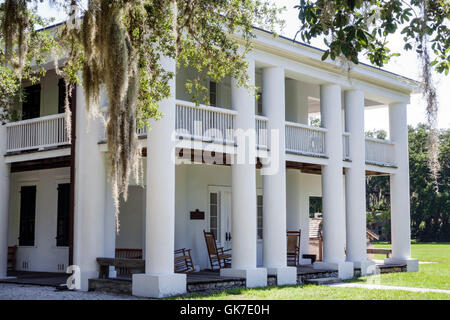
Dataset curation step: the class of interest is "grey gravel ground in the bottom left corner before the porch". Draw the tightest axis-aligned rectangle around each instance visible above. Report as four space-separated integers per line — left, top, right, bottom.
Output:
0 283 139 300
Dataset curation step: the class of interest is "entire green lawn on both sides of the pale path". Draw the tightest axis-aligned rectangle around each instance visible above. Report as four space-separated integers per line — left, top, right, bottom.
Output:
173 243 450 300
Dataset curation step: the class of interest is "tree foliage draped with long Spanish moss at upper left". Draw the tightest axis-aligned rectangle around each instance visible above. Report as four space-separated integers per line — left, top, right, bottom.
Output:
0 0 279 230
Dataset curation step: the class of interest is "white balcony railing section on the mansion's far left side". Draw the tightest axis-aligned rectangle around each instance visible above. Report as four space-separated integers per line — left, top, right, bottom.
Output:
6 113 70 152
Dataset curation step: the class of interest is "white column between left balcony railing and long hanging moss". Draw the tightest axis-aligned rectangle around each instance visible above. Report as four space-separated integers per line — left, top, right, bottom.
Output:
74 87 106 291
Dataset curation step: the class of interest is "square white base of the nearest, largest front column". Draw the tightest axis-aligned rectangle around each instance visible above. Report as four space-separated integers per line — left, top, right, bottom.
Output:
131 273 186 298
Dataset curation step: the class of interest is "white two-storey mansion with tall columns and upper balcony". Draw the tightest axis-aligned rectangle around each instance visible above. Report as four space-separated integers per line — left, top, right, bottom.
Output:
0 30 418 297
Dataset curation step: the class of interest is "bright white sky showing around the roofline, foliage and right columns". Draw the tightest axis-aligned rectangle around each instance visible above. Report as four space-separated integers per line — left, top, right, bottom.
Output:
39 0 450 131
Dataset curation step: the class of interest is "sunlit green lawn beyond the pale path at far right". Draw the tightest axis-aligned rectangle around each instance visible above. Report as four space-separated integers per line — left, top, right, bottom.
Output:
352 242 450 290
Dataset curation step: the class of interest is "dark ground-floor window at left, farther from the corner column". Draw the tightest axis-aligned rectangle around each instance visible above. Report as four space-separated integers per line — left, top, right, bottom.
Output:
19 186 36 246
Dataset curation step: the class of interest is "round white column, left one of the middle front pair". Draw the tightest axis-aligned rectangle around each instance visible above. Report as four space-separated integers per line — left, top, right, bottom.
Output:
220 58 267 287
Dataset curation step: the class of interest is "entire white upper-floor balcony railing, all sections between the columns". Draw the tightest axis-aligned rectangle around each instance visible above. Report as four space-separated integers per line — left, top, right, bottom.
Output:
6 104 395 166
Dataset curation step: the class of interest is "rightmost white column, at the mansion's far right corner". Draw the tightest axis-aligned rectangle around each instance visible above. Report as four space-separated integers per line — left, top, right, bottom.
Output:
385 103 419 271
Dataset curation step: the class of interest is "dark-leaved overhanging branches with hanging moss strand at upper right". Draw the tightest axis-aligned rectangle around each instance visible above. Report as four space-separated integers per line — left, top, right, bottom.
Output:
296 0 450 185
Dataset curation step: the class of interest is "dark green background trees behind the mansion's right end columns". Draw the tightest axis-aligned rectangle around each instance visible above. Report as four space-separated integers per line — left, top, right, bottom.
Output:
366 124 450 241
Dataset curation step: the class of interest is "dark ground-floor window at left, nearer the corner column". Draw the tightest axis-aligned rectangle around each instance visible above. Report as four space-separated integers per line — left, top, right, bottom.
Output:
56 183 70 247
